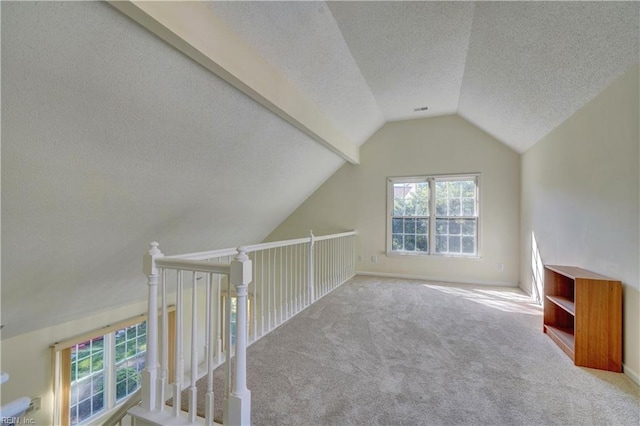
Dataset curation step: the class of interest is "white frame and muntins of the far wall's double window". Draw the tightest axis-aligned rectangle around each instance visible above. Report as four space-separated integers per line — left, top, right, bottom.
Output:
386 173 482 259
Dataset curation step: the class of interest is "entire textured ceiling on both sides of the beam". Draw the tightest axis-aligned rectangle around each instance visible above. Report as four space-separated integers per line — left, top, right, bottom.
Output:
1 1 640 338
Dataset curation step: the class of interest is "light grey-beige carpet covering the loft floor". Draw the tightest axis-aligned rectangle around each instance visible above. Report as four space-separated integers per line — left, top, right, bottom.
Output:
178 277 640 426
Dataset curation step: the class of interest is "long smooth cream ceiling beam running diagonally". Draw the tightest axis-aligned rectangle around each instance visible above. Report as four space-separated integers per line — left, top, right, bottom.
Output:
109 1 360 164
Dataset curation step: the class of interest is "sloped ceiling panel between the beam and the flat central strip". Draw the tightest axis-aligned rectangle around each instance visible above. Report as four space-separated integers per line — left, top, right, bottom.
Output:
208 1 385 144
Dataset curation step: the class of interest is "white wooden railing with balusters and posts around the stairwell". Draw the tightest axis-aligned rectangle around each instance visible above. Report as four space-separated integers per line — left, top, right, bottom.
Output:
131 231 357 425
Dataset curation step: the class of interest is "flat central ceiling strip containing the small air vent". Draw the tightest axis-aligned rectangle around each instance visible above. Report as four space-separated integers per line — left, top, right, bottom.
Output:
330 2 474 121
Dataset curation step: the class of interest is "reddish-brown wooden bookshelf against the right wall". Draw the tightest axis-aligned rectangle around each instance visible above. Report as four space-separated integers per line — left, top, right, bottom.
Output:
543 265 622 372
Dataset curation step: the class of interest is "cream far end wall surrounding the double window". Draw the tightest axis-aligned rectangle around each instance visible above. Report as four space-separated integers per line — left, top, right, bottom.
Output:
267 115 520 285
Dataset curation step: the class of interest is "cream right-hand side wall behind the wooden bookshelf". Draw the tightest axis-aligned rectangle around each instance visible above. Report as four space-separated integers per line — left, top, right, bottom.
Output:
520 66 640 381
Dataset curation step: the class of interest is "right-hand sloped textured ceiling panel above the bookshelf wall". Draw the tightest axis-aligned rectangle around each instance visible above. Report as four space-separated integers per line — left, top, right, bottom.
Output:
458 2 640 152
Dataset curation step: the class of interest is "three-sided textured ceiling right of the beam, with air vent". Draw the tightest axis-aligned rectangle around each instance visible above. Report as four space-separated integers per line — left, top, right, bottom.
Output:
210 1 640 152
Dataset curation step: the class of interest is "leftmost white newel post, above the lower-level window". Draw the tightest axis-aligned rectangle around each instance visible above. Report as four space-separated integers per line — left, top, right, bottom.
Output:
142 241 163 411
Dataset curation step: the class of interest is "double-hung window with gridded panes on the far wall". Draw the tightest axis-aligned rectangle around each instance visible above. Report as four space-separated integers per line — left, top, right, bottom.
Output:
387 174 479 257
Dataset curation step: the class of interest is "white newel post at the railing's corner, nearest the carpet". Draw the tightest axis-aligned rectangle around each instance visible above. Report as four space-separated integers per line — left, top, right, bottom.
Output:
224 247 252 426
